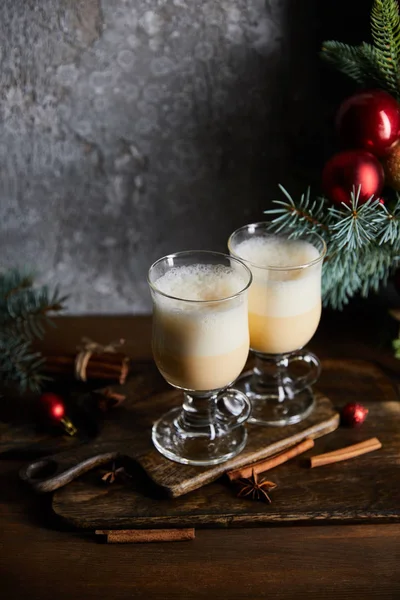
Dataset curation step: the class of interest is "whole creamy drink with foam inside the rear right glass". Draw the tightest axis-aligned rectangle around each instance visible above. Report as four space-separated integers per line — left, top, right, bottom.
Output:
234 237 321 354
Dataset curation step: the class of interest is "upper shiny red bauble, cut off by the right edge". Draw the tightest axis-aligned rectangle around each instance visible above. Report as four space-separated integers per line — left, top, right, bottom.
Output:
336 90 400 156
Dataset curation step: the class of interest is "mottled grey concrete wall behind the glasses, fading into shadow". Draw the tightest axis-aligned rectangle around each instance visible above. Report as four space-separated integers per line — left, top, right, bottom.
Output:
0 0 356 313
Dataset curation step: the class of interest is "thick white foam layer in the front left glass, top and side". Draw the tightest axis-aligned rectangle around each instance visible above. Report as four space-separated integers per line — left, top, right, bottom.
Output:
153 264 249 356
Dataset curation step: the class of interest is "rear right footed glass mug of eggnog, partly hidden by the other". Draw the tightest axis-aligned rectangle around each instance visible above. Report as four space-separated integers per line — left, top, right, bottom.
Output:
228 222 326 425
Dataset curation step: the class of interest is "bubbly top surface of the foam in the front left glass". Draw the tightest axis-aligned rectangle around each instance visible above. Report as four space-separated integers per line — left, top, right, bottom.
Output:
155 264 246 301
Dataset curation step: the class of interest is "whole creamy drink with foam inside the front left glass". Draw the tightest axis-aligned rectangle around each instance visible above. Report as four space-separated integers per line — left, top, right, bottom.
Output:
153 267 249 391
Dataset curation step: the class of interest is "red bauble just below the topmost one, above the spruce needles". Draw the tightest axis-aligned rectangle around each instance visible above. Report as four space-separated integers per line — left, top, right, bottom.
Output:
322 150 385 205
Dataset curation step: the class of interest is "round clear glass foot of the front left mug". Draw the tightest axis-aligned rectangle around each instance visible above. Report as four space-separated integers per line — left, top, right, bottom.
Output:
152 407 247 466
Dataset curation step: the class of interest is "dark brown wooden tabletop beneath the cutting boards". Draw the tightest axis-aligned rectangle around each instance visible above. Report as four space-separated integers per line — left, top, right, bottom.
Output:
0 309 400 600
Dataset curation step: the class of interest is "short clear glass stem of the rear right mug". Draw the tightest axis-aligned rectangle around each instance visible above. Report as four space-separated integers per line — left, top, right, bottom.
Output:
251 352 291 402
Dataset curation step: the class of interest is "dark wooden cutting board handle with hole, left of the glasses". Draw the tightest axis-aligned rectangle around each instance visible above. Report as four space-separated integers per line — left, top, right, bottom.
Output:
19 448 120 493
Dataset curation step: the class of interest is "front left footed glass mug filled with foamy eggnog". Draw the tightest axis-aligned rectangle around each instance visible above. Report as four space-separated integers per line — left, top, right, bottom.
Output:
148 251 252 465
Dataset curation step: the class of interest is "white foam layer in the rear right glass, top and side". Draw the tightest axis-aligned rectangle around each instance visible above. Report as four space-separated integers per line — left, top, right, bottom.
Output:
234 235 321 317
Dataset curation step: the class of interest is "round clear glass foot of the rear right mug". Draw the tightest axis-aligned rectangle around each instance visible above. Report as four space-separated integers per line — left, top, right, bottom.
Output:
235 374 315 427
